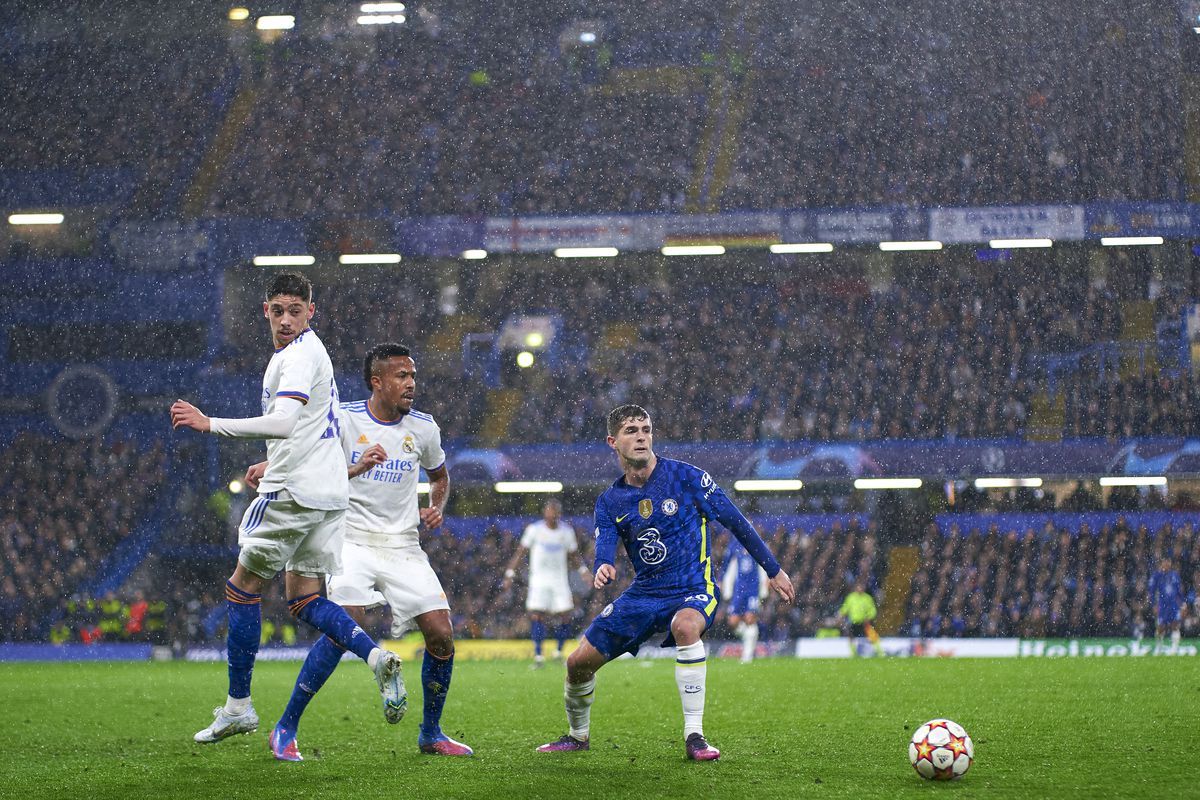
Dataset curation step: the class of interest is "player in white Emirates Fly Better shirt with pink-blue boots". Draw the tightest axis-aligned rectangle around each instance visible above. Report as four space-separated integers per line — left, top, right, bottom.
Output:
246 343 473 762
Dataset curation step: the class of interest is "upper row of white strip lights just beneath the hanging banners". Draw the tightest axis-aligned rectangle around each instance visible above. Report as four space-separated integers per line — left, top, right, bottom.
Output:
246 236 1163 266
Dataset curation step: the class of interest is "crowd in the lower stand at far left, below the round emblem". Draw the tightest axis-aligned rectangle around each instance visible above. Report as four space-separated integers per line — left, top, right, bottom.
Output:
0 433 166 640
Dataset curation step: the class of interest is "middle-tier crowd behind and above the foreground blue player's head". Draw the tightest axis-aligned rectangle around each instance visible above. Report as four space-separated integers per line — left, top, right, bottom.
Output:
494 260 1132 441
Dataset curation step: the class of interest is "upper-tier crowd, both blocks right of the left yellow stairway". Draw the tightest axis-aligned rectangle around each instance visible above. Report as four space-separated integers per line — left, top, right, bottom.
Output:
196 0 1184 217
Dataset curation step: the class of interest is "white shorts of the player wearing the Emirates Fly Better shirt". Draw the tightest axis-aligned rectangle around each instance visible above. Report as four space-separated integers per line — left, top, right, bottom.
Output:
325 542 450 637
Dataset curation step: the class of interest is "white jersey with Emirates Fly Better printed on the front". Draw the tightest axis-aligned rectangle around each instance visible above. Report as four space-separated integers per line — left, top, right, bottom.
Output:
338 401 446 547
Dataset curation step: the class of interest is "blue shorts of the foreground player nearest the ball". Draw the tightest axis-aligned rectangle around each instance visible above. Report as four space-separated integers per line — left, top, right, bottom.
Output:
583 588 720 658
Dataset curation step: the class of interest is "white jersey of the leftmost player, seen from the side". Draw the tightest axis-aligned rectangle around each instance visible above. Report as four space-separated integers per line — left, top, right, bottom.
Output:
258 329 348 511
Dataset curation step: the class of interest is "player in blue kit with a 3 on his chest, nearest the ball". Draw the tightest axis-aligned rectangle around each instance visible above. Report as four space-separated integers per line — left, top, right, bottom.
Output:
538 405 796 760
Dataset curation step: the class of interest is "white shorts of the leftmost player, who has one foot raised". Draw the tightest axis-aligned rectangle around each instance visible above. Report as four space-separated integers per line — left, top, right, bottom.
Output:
238 489 346 581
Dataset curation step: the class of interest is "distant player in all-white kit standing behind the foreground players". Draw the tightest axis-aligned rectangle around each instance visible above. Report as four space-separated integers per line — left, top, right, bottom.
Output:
503 500 590 668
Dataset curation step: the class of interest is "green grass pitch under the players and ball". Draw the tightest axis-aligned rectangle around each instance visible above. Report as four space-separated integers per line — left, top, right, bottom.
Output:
0 658 1200 800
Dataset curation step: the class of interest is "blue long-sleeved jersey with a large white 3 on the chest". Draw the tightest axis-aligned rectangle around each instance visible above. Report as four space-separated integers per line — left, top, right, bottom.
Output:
595 458 779 595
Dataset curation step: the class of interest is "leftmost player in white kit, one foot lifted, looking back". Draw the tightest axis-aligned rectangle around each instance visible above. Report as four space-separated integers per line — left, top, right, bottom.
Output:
170 272 403 744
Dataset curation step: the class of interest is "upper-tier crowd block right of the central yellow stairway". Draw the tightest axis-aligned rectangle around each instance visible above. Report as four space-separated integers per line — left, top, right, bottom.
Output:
721 1 1184 209
